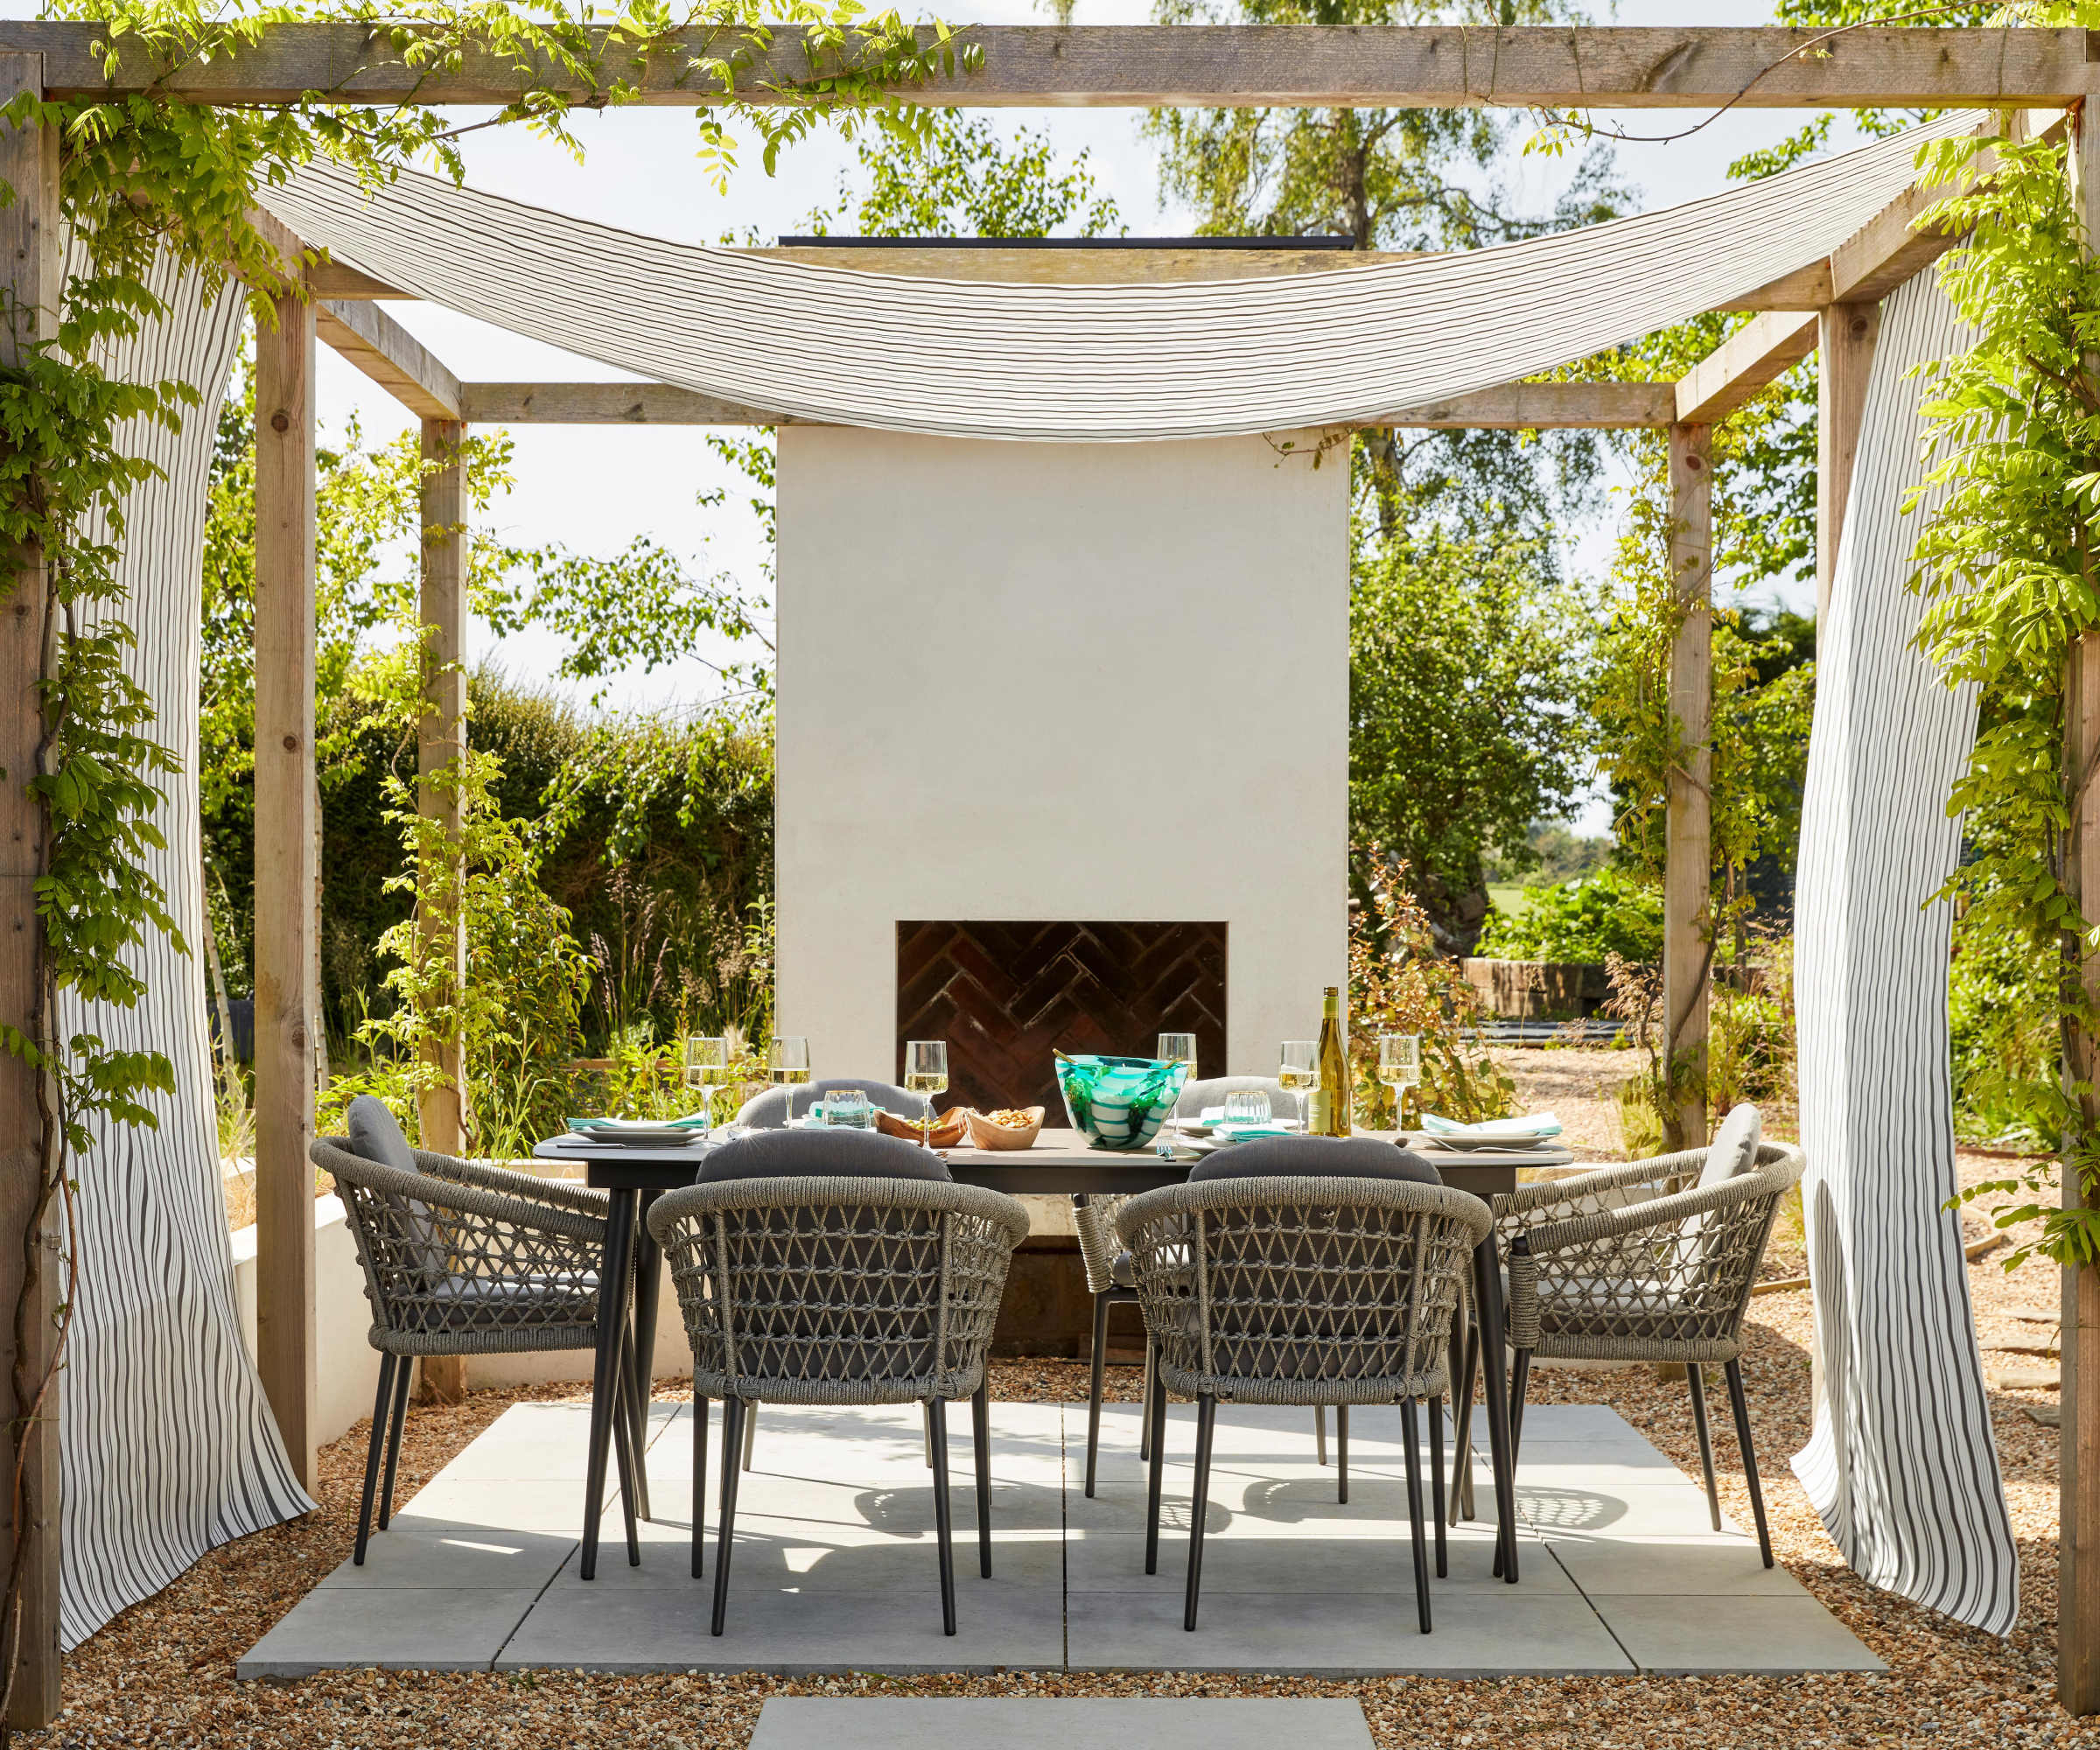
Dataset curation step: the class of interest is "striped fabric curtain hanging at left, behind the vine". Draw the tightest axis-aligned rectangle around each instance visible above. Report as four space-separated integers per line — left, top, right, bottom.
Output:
59 258 313 1647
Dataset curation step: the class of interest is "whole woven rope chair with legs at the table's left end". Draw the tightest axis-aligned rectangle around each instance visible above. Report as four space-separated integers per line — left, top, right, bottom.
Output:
311 1137 640 1565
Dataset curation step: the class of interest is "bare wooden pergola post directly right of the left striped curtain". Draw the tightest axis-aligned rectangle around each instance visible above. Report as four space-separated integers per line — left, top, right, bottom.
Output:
254 288 319 1489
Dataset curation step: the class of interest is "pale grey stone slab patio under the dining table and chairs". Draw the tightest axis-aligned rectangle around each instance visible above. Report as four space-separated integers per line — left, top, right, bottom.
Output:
240 1404 1881 1676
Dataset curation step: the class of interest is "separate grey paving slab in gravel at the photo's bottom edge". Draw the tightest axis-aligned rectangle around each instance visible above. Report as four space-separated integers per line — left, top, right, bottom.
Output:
752 1696 1371 1750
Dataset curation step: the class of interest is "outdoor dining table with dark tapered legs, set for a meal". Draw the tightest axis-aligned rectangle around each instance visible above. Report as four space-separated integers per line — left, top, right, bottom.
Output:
534 1128 1573 1584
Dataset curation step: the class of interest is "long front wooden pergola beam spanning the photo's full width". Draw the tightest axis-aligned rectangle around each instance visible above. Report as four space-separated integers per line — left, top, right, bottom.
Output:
0 21 2088 109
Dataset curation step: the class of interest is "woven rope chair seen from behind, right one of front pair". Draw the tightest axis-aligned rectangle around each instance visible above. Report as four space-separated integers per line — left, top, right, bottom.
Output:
1115 1177 1491 1634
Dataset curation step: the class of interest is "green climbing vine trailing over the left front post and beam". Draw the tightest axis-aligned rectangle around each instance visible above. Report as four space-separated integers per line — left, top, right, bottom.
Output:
0 0 981 1744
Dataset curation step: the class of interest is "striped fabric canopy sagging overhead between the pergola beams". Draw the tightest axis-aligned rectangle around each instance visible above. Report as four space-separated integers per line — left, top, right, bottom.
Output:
264 116 1978 441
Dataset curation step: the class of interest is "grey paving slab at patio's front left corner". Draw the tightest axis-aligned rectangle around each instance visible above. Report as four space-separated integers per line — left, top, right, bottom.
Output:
233 1588 540 1678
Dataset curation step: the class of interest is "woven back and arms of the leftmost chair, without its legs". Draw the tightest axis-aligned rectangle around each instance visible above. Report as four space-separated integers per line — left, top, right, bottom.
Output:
311 1137 605 1353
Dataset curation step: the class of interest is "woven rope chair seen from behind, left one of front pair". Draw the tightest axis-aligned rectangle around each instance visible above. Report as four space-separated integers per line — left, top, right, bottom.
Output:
649 1179 1029 1634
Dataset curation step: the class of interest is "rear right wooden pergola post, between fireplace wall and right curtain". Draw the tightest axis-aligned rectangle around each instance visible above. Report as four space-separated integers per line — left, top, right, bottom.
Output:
1663 424 1713 1149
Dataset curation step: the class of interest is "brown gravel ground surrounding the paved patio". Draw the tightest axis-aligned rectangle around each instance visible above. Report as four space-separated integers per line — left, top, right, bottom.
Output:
25 1159 2100 1750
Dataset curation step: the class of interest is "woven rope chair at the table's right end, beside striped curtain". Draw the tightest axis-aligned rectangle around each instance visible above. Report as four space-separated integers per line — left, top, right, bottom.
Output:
1495 1143 1804 1567
